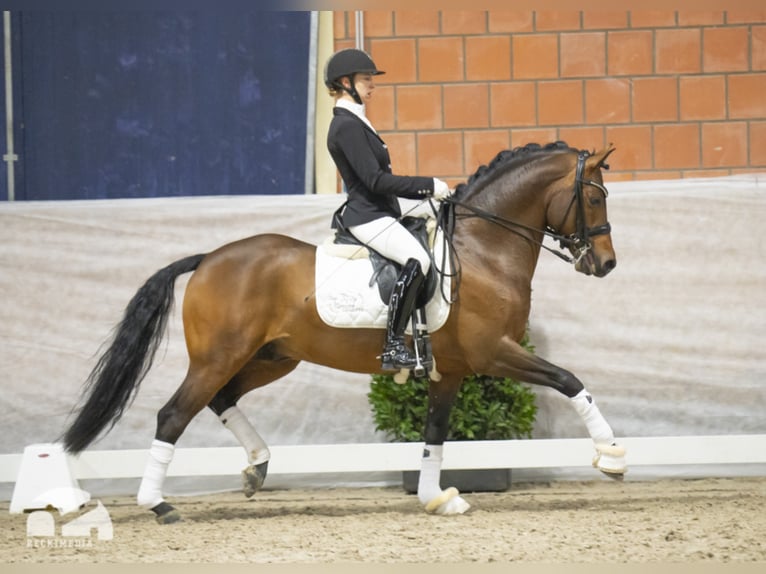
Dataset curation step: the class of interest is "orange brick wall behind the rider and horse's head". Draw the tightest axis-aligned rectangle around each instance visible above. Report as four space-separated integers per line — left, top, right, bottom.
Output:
334 9 766 183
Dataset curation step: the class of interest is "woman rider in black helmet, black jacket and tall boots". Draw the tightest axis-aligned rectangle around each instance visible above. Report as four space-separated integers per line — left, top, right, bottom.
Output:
325 48 453 370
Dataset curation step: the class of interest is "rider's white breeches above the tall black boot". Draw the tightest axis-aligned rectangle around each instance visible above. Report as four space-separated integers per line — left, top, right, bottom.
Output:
348 217 431 275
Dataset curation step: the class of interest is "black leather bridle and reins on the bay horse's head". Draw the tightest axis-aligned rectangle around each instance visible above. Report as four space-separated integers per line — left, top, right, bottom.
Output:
441 150 612 265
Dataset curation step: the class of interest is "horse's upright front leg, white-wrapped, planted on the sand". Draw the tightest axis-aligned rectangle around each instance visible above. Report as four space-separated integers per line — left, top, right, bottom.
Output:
418 376 471 514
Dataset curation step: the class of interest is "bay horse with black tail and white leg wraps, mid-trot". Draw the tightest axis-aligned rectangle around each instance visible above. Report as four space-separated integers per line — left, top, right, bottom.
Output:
61 142 626 524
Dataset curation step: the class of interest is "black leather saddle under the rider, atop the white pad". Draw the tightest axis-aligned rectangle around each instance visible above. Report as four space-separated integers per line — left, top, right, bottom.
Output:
333 212 437 307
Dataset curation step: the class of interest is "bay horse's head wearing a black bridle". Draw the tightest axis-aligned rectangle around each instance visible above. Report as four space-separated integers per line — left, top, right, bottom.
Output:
547 145 617 277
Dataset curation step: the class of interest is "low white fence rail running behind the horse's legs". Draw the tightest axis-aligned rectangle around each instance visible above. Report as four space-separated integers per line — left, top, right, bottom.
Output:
0 435 766 482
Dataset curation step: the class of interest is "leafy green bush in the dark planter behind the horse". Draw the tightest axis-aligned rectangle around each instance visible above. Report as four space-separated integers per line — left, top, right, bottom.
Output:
367 337 537 442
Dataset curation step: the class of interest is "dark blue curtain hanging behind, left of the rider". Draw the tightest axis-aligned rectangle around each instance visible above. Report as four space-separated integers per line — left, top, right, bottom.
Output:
9 11 310 200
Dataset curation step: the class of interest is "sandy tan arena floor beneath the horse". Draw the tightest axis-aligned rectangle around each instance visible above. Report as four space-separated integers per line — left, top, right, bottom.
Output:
0 478 766 564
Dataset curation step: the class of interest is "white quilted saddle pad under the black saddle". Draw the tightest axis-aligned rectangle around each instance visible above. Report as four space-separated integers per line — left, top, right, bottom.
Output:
314 233 451 334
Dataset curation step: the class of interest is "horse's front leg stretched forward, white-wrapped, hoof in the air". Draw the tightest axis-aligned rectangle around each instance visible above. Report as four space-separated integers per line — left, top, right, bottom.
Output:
486 339 627 479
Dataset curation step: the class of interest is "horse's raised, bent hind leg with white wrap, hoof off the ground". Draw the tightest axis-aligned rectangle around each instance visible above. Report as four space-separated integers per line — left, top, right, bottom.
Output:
208 359 299 498
